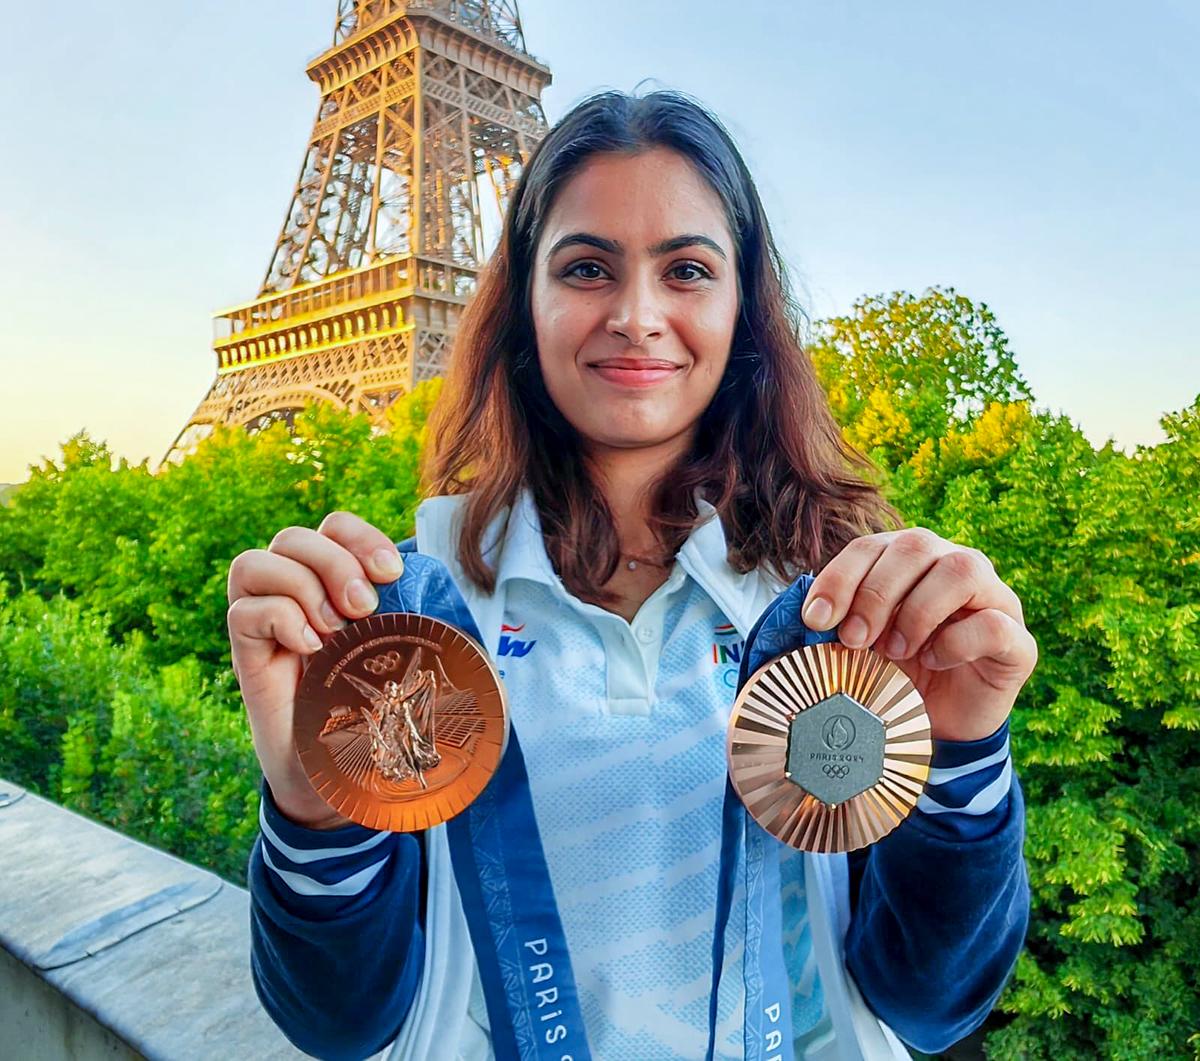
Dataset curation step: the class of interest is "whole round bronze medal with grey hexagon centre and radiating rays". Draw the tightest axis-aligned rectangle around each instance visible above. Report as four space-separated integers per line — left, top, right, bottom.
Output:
726 642 932 853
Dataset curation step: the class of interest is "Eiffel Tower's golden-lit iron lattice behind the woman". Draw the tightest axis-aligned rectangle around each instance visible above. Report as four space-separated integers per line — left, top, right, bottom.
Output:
164 0 551 462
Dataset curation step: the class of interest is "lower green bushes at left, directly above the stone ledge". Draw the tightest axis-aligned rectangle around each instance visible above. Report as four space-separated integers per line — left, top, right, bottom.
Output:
0 583 259 882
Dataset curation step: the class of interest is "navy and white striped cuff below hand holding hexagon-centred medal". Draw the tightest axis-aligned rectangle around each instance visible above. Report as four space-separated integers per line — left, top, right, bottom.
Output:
917 719 1013 840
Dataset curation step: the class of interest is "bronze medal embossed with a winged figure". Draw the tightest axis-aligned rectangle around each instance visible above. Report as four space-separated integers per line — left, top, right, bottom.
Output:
295 612 509 833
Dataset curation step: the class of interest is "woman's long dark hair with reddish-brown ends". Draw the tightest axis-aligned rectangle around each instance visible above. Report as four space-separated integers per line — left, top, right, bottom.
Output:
422 91 901 603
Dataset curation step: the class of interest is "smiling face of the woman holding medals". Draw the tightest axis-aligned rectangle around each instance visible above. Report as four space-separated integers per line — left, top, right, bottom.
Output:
530 148 738 455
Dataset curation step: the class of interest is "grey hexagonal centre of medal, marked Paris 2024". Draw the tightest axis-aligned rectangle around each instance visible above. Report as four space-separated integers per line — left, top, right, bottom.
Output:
786 693 884 805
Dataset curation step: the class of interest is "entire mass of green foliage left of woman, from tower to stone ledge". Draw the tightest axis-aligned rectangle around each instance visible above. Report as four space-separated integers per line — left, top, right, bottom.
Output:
0 380 440 882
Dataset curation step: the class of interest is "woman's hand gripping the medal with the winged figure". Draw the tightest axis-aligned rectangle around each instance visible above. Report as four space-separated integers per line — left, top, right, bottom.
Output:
226 512 404 829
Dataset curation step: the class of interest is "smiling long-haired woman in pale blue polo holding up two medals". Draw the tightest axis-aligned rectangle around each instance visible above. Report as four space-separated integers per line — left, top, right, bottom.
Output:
229 92 1037 1059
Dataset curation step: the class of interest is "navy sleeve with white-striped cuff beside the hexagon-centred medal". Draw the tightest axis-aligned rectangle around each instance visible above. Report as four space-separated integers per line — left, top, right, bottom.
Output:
846 723 1030 1054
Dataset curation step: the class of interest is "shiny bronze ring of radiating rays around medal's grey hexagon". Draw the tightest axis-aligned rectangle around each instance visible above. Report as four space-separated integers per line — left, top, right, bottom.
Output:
728 638 932 853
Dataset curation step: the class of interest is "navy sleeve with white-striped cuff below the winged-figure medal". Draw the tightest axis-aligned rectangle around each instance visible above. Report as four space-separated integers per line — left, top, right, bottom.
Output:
247 779 425 1061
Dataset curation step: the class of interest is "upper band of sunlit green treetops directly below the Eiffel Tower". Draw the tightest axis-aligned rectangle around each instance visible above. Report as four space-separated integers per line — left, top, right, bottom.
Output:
0 379 442 667
